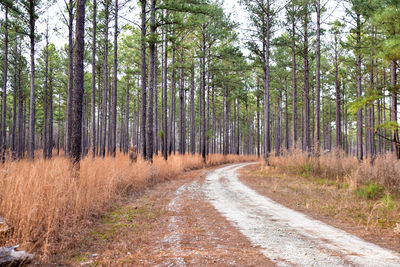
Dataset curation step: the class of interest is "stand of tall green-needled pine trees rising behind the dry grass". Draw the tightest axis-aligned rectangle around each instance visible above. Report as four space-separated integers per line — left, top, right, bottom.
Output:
0 0 400 164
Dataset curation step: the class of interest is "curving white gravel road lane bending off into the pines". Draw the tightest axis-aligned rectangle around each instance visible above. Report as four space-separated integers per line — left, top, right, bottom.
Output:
203 163 400 266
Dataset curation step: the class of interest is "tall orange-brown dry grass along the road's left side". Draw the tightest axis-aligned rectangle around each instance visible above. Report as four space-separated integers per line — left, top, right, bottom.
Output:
0 154 256 256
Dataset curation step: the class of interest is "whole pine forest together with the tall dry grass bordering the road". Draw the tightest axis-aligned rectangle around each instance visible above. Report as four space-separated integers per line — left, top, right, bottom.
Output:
0 0 400 264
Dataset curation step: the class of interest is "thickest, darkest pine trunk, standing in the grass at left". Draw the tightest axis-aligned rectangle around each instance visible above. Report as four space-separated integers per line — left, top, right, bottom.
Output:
70 0 86 166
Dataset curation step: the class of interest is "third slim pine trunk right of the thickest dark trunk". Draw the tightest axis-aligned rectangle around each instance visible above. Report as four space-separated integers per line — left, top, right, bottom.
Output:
110 0 118 157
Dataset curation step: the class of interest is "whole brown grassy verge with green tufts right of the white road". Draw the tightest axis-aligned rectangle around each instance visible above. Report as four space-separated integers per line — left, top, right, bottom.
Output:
241 150 400 251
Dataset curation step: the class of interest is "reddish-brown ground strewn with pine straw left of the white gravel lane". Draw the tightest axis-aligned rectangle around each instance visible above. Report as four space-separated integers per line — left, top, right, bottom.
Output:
52 167 274 266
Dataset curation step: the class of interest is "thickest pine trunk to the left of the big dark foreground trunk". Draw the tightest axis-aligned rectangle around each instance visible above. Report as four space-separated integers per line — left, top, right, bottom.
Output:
28 0 36 160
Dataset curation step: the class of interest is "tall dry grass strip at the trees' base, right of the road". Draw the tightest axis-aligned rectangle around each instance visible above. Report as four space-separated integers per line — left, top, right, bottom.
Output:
270 150 400 191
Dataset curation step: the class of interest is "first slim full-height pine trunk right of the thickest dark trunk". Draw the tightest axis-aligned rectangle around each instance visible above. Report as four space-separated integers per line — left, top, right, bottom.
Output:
92 0 97 158
